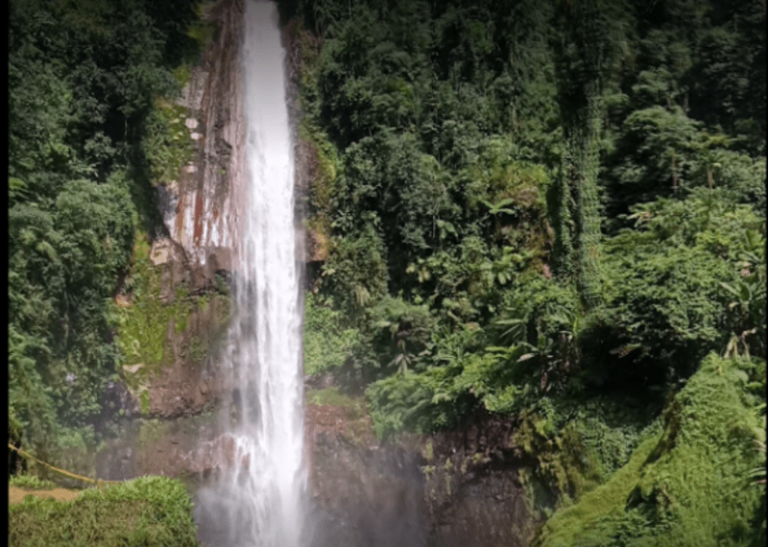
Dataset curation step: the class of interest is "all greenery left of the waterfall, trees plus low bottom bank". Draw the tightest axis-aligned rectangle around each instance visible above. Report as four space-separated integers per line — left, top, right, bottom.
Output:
8 0 209 546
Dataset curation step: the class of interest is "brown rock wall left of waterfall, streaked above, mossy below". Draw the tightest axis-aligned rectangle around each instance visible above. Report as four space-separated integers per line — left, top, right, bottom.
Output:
96 0 246 479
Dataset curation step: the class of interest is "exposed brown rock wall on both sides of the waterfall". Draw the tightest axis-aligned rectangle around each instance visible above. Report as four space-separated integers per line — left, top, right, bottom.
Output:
96 0 532 547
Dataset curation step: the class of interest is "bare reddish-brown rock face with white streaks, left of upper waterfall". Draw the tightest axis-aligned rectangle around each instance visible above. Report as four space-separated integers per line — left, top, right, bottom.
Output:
158 0 245 291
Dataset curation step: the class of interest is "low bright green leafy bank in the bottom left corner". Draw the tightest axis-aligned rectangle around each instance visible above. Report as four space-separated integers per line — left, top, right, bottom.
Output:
8 477 199 547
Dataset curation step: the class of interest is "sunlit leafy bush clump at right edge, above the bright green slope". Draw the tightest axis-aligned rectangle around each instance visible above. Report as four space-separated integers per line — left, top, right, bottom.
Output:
597 193 765 382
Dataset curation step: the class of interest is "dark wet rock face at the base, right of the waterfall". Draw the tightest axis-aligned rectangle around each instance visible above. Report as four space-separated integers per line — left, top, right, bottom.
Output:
307 412 537 547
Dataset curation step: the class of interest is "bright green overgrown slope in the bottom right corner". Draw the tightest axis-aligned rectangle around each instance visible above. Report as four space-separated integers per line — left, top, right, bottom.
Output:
533 355 761 547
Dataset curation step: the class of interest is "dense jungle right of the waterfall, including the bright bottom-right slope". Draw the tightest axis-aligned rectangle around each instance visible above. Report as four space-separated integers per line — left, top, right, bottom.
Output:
290 0 766 546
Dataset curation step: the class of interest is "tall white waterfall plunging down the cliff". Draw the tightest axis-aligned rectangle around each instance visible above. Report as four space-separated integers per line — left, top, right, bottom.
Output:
197 0 306 547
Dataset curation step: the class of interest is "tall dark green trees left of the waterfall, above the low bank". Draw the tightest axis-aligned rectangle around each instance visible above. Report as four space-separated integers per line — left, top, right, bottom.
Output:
8 0 204 463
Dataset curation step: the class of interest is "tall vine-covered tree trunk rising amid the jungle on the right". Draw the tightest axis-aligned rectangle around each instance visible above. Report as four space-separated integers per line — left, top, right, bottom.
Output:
554 0 627 308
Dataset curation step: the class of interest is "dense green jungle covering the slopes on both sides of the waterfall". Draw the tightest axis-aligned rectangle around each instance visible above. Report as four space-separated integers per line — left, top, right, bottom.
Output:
8 0 766 546
